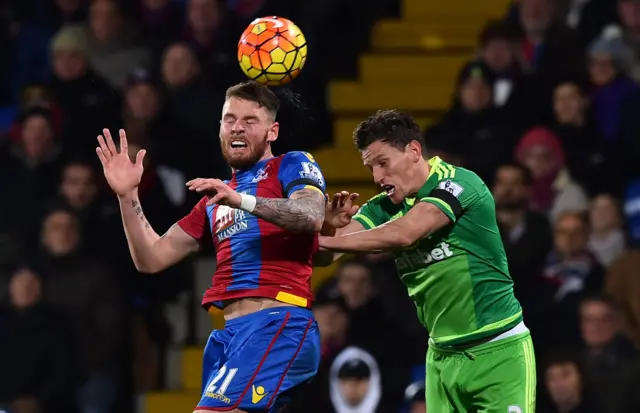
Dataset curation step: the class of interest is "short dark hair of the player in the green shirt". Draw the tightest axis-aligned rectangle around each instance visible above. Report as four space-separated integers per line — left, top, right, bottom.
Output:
353 109 427 154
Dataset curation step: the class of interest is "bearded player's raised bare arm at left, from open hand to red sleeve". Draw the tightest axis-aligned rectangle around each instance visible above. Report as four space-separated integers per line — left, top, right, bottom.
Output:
96 129 199 273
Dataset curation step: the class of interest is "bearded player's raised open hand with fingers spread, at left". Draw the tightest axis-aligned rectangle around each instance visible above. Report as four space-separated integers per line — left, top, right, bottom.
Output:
96 129 146 197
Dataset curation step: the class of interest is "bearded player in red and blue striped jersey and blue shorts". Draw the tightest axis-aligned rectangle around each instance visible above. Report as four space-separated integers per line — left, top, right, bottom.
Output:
97 82 325 413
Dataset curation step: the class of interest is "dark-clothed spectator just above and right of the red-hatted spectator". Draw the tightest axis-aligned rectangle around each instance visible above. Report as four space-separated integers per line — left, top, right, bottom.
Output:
553 82 621 195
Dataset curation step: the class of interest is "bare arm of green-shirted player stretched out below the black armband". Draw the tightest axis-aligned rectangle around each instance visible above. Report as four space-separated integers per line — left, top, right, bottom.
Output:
320 202 451 252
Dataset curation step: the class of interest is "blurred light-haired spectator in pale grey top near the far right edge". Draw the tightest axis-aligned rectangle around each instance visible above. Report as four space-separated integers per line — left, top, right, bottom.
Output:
589 194 626 268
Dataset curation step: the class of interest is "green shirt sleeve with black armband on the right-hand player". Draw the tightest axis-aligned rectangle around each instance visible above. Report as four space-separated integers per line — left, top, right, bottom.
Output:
418 179 479 222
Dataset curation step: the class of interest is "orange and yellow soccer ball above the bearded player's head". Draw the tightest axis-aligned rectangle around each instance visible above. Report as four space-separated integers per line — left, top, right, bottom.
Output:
238 16 307 86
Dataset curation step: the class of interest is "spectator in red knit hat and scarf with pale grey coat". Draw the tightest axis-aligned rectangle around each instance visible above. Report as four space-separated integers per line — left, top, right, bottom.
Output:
515 127 589 222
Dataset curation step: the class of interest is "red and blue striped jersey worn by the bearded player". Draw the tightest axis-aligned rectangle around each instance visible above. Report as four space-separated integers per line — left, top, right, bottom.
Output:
178 152 326 308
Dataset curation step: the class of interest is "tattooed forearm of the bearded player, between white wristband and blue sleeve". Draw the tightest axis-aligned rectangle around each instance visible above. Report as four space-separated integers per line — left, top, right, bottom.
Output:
252 189 324 232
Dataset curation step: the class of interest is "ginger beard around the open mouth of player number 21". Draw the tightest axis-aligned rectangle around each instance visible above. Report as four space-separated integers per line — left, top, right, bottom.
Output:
220 130 269 169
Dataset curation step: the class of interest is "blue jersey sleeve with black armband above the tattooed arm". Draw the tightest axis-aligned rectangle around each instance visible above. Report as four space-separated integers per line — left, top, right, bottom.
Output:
278 152 327 198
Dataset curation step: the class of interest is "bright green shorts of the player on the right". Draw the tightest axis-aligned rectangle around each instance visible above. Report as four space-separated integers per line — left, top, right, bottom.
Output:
426 332 536 413
